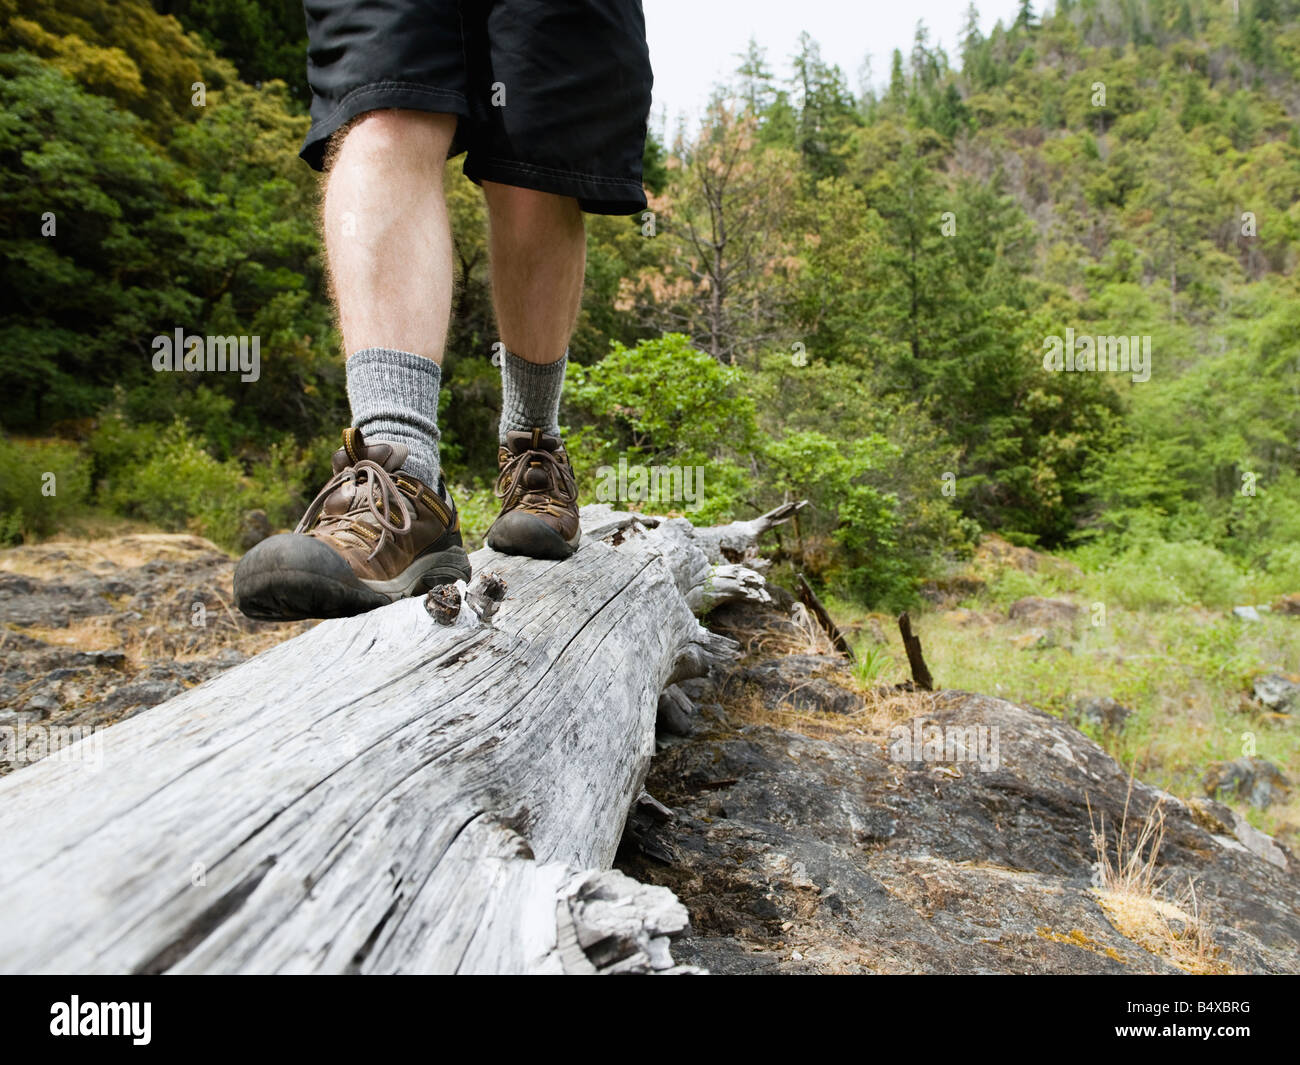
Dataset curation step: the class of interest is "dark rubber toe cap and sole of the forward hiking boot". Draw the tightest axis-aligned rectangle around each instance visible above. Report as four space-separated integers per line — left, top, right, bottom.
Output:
234 533 472 622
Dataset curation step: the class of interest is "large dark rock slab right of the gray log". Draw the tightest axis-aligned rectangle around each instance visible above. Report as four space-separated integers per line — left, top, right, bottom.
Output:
620 631 1300 973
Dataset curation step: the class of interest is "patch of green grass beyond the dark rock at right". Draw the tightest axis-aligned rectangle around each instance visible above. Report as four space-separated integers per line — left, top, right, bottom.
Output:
829 545 1300 847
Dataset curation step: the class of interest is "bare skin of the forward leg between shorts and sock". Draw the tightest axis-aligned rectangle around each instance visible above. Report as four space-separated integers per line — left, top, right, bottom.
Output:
324 111 456 364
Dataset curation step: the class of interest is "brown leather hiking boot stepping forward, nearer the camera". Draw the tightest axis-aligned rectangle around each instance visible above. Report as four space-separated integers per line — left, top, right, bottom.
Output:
235 429 469 622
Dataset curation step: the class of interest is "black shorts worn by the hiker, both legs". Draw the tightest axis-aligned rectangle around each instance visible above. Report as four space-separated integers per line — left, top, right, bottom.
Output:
302 0 653 215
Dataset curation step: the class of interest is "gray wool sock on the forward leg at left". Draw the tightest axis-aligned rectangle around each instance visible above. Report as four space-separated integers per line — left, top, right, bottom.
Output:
347 347 442 490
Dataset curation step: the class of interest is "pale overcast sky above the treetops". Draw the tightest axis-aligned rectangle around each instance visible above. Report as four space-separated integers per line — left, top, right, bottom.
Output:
644 0 1024 131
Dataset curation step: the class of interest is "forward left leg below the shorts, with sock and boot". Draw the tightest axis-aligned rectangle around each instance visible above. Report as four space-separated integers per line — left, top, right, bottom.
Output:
234 111 471 620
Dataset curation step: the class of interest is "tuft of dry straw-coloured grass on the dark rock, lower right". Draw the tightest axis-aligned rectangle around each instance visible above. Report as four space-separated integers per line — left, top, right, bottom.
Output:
1088 774 1232 974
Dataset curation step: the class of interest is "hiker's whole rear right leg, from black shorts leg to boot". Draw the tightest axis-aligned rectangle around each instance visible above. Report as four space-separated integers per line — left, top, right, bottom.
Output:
465 0 653 559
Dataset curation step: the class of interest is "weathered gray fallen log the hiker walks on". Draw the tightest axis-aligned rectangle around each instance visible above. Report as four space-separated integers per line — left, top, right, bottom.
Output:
0 507 738 973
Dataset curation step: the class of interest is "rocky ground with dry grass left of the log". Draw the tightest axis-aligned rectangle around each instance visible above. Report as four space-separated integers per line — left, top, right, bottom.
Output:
0 533 312 774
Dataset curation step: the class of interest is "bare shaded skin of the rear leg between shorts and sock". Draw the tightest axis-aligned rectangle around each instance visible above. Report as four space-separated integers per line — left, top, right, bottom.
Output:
484 181 586 364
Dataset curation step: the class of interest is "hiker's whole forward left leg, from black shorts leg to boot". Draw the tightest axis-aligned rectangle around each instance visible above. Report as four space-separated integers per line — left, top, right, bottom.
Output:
234 0 478 620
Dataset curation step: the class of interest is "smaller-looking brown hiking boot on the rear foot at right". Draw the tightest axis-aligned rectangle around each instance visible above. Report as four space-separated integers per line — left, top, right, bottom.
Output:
488 429 582 558
